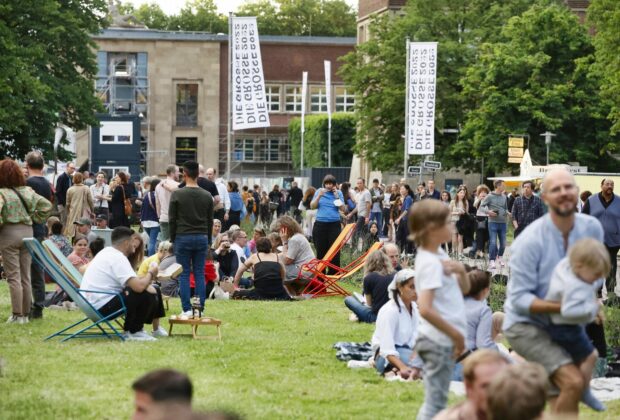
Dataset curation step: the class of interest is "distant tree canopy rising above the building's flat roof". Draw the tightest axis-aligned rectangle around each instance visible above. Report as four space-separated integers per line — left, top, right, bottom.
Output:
124 0 357 36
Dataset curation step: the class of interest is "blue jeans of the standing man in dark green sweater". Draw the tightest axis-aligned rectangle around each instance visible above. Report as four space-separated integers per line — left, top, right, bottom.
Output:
174 234 209 312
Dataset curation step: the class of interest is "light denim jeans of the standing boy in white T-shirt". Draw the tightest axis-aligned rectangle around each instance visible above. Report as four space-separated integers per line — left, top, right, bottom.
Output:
415 336 454 420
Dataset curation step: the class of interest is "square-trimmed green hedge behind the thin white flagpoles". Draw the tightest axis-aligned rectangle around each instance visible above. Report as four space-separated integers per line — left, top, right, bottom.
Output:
288 113 356 168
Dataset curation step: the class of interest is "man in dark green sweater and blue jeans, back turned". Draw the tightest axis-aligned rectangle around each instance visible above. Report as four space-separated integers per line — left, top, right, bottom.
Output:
168 161 213 316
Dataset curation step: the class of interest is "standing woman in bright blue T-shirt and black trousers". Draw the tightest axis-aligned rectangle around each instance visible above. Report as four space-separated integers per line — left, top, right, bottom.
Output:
310 175 345 267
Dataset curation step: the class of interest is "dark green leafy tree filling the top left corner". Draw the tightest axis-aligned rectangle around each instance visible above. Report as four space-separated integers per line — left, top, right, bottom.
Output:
0 0 107 158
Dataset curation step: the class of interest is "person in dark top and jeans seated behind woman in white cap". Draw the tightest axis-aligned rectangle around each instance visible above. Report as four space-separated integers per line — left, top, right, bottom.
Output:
344 249 394 324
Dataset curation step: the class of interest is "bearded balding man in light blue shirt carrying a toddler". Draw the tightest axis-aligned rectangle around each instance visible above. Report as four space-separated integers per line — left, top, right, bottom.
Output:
503 169 603 415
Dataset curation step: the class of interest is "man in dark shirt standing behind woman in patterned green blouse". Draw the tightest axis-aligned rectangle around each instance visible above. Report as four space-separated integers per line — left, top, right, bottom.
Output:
26 152 52 319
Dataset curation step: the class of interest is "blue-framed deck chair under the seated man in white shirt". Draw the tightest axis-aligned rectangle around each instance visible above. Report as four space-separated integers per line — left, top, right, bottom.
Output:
24 238 127 341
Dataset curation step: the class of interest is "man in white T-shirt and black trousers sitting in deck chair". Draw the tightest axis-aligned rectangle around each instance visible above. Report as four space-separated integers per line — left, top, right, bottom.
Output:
81 226 167 341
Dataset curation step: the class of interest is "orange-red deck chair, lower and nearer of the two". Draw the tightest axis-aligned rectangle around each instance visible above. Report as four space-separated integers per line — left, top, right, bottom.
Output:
300 242 383 298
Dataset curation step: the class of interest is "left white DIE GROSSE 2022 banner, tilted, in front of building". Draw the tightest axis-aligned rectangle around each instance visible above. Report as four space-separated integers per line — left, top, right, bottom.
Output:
229 17 269 131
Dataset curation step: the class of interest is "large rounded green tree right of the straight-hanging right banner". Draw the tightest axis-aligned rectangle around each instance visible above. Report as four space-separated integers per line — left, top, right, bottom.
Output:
458 1 617 171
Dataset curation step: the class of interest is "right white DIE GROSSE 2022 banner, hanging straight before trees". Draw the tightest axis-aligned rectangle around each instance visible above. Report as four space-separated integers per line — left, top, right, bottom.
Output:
406 42 437 155
